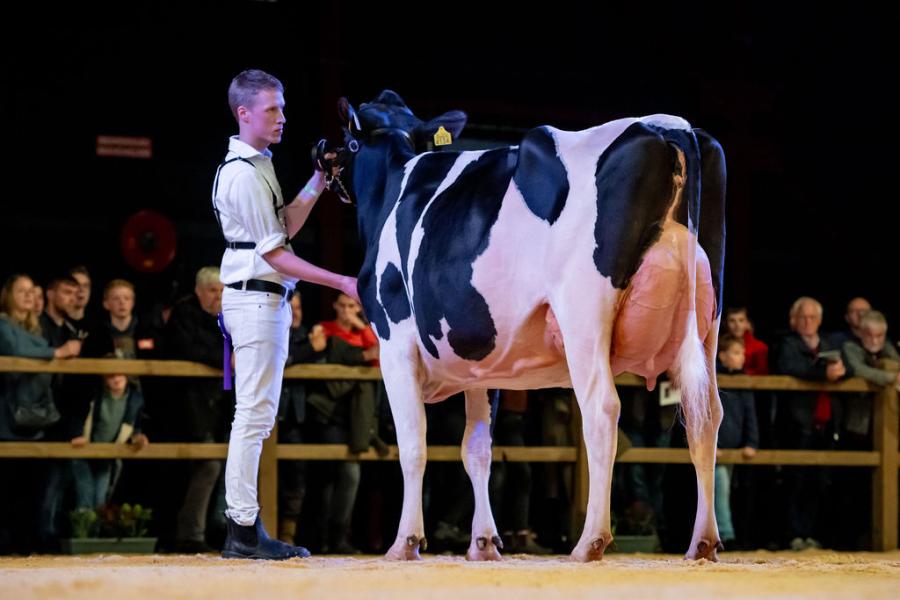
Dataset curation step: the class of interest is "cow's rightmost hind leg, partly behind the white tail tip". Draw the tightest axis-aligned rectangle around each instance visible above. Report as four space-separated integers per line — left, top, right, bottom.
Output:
682 319 723 561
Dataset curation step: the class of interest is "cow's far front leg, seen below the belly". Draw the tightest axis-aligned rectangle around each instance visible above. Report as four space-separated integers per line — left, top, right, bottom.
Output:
462 389 503 560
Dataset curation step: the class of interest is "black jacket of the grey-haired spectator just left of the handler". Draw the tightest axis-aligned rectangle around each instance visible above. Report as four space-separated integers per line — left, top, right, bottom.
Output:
160 295 234 442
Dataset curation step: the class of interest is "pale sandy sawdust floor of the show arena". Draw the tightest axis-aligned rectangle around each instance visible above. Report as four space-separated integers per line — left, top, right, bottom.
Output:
0 551 900 600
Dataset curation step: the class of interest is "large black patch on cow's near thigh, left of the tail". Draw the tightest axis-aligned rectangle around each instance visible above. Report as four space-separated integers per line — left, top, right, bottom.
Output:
594 123 677 289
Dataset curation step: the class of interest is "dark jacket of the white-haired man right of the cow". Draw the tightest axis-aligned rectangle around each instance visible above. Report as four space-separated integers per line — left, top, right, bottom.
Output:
775 333 841 431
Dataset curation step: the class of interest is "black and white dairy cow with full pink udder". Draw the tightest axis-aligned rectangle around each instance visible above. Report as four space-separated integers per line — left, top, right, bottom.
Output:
340 91 725 561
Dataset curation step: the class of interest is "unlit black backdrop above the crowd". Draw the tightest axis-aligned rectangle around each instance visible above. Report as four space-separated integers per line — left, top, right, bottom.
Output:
0 1 900 337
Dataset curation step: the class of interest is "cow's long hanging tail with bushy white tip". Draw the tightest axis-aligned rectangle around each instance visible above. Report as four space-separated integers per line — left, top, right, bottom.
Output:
672 144 712 435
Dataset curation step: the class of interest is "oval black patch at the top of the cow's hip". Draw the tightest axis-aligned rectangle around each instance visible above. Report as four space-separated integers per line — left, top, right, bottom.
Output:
514 127 569 225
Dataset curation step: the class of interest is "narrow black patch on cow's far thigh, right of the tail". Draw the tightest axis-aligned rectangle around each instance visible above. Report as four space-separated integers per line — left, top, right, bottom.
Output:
694 129 726 317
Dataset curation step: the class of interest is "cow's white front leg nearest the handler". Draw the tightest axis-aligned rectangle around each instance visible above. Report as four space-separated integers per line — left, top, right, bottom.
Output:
381 358 427 560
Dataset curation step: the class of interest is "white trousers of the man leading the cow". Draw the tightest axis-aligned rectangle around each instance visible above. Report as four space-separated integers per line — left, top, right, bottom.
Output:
222 288 291 525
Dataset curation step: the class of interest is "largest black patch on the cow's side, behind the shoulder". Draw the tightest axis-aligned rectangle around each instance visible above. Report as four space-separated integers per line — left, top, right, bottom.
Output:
406 148 518 360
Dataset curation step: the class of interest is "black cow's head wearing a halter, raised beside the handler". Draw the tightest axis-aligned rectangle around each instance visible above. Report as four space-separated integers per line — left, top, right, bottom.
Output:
336 90 467 201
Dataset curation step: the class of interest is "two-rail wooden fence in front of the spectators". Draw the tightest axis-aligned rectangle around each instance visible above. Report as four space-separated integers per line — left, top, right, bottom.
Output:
0 357 900 550
